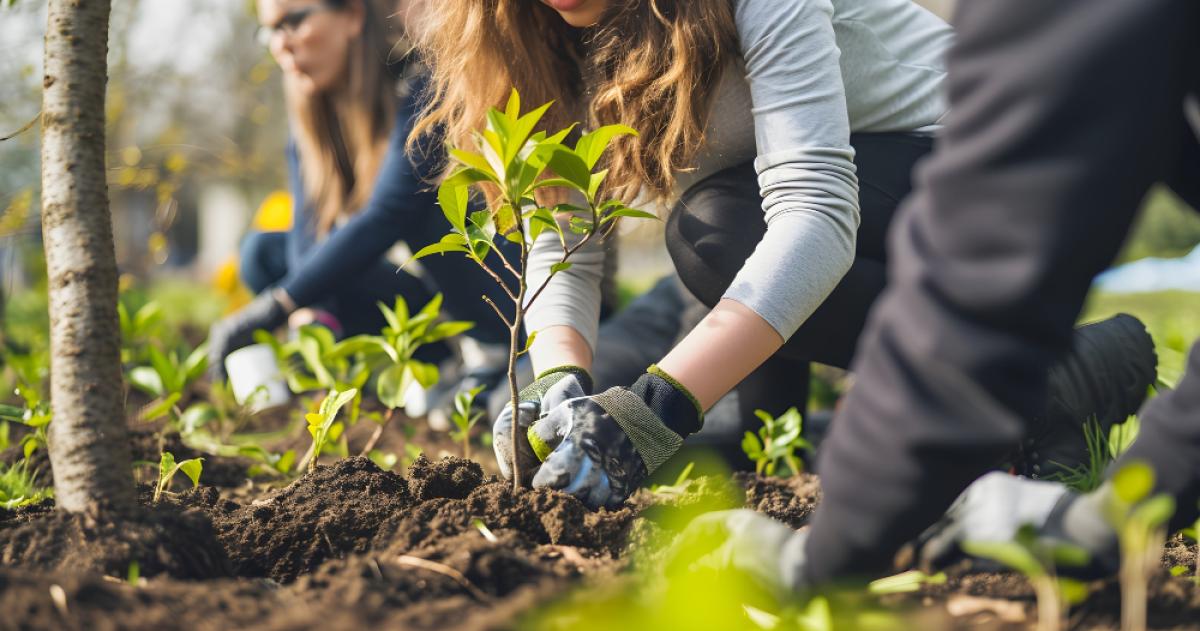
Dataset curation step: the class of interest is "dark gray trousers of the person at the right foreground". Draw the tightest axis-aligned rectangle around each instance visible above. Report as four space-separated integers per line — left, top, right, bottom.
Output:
806 0 1200 581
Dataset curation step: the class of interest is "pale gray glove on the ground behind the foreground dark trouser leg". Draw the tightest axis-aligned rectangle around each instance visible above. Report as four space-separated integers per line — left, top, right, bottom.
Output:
917 471 1120 578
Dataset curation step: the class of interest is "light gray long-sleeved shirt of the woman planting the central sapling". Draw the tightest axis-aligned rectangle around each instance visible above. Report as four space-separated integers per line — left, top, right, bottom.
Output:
526 0 952 350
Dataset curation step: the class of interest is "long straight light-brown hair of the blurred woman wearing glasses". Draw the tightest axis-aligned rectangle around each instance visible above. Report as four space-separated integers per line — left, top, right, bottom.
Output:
284 0 400 235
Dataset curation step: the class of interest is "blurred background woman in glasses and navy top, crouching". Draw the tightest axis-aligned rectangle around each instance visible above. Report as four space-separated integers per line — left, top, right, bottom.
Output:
210 0 508 393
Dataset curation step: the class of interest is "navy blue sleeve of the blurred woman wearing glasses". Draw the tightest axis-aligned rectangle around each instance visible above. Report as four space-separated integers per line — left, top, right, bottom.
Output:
281 76 440 307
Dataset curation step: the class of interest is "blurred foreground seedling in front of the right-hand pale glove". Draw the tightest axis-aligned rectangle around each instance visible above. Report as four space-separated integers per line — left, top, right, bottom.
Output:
962 525 1090 631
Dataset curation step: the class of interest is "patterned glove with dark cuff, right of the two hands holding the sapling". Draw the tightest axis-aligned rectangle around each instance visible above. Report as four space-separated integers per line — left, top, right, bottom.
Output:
529 366 703 509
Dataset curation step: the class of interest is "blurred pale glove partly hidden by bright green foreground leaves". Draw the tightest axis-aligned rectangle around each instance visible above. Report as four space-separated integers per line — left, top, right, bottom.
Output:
666 509 809 601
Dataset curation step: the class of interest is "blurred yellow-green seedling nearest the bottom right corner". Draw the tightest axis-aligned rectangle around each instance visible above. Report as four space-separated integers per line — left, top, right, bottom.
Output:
1104 462 1175 631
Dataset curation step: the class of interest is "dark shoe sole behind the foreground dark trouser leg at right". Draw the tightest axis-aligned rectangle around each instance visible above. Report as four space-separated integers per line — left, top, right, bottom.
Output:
1014 313 1158 479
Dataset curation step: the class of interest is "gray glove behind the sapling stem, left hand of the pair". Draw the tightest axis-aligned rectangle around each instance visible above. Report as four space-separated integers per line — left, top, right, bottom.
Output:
492 366 592 486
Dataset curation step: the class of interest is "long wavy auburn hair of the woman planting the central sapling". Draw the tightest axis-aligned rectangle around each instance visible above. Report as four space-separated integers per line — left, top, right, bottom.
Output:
410 0 738 200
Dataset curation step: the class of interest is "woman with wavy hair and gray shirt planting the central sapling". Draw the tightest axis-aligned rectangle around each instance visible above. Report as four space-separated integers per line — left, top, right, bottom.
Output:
415 0 1154 506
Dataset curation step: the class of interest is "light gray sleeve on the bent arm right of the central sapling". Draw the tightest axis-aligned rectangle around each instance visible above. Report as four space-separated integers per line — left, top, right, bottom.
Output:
724 0 859 339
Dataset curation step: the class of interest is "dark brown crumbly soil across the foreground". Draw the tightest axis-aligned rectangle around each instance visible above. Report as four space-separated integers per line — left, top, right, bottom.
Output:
0 437 1200 630
